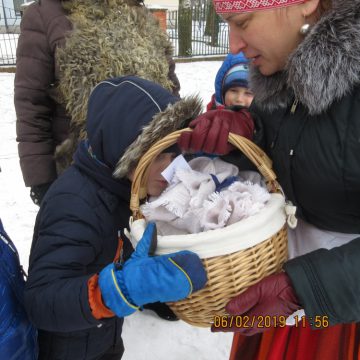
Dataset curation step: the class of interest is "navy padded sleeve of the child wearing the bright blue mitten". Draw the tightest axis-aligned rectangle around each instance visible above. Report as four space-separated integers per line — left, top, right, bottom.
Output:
25 194 101 332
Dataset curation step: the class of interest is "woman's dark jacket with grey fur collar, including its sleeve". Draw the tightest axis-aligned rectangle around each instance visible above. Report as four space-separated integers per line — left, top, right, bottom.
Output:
251 0 360 324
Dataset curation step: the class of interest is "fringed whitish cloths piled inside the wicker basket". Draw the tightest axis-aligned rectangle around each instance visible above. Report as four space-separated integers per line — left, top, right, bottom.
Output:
141 157 270 235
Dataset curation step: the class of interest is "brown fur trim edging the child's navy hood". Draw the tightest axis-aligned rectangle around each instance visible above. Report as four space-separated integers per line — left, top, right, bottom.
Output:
114 96 202 178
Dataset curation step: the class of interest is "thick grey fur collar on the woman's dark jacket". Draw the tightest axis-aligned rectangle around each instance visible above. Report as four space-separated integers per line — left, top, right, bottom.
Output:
250 0 360 115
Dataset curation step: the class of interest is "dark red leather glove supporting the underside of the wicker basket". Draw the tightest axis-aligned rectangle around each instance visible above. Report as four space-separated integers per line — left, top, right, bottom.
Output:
211 272 301 335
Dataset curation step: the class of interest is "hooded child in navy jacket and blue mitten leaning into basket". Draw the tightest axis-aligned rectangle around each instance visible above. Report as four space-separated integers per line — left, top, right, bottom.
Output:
25 76 206 360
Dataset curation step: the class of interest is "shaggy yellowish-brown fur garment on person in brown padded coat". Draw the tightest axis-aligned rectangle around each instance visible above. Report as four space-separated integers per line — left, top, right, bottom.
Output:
55 0 178 172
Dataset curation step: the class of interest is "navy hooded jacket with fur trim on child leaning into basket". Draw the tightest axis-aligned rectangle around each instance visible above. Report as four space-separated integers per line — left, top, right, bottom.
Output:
25 76 201 360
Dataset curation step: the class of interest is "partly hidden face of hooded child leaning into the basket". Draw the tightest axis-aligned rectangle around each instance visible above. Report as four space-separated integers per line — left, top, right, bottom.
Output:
147 153 176 196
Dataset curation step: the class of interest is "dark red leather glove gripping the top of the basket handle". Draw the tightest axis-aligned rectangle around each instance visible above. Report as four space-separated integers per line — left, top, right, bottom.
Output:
178 108 255 155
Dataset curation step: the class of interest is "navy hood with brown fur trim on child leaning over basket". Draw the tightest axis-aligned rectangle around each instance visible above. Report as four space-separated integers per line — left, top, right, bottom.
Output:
75 76 202 183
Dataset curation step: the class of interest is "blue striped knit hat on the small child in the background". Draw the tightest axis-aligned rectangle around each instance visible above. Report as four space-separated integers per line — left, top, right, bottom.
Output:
215 53 249 105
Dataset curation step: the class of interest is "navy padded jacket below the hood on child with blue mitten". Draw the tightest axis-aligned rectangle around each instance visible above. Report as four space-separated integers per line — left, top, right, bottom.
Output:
25 166 130 360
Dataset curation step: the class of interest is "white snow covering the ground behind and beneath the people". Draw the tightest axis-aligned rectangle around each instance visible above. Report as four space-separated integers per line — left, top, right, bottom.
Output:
0 61 232 360
